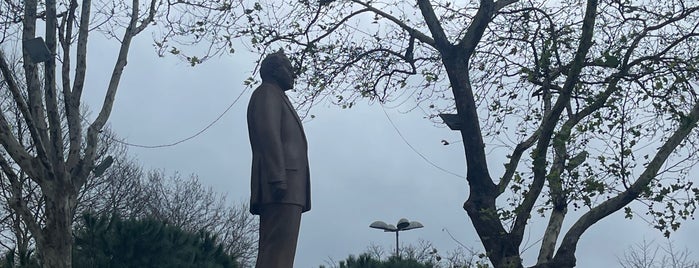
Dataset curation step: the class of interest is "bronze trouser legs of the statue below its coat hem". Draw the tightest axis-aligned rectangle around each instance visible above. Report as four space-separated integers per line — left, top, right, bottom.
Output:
255 204 301 268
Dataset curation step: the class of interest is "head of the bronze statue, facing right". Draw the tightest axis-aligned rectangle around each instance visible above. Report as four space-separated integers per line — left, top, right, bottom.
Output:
260 49 296 90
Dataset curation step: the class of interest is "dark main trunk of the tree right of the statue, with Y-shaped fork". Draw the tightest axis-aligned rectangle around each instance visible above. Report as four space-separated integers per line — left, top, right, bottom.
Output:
418 0 522 268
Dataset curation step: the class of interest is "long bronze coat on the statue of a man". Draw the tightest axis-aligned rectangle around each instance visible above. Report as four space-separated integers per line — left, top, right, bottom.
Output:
247 82 311 215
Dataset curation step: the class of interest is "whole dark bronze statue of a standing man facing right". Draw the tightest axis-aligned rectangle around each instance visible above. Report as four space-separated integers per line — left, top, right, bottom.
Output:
248 51 311 268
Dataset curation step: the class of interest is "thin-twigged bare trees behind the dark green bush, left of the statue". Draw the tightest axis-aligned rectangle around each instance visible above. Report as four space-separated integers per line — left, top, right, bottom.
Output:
0 122 257 267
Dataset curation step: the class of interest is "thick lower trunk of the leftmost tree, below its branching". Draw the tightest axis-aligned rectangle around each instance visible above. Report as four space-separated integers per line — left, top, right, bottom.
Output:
39 183 75 268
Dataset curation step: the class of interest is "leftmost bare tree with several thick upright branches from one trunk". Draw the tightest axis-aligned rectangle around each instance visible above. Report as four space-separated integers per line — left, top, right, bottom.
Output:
0 0 155 267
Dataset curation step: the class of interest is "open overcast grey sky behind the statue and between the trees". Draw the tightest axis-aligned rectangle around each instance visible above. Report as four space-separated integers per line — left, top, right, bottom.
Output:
78 28 699 268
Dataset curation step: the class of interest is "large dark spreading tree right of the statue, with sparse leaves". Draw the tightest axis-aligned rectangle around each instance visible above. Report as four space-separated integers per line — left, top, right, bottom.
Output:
238 0 699 268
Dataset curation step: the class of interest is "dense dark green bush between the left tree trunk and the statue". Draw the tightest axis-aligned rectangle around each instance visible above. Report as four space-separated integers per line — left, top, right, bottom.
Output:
73 214 237 268
